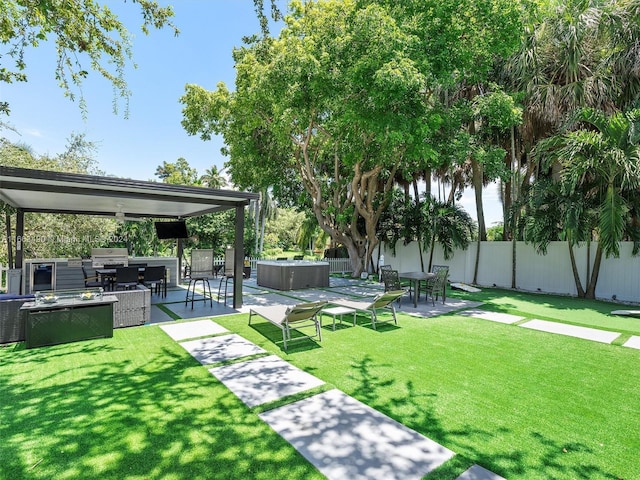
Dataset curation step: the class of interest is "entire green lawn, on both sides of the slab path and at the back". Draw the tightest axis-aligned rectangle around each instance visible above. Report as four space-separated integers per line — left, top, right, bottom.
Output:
0 290 640 479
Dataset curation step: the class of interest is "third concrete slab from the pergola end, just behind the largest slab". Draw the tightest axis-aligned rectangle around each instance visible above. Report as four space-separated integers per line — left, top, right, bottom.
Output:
209 355 324 407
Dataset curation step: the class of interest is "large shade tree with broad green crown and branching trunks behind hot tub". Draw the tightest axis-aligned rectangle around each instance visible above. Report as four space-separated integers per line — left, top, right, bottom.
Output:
181 1 433 275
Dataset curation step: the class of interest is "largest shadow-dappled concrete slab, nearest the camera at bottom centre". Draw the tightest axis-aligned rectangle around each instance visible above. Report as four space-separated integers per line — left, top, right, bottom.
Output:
260 390 454 480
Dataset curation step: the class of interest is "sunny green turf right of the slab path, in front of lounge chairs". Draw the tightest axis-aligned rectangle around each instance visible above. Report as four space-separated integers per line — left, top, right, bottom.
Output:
216 313 640 479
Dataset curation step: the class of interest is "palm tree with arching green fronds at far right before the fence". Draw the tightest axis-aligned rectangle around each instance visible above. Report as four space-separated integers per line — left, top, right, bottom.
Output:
535 108 640 298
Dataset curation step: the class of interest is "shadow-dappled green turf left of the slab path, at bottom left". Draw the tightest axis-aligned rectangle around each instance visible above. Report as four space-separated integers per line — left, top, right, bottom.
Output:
0 327 322 480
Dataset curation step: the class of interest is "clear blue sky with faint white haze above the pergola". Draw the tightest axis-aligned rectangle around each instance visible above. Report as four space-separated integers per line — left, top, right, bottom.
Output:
0 0 501 226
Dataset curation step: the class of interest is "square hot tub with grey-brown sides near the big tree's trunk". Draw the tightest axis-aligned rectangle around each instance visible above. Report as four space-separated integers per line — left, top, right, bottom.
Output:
257 260 329 290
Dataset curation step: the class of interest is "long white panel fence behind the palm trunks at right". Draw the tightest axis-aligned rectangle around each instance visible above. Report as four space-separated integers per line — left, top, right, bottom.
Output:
376 242 640 303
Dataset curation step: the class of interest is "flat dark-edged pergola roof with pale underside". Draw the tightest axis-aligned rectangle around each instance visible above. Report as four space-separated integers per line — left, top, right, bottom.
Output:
0 166 259 218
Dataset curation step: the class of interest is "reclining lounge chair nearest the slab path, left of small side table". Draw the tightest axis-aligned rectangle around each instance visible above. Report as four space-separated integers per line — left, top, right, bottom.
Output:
249 302 327 350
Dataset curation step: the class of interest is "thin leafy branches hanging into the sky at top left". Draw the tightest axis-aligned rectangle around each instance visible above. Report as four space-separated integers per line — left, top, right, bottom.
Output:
0 0 179 113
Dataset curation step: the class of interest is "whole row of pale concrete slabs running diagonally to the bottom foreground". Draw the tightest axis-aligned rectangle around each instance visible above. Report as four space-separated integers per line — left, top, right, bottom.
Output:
160 320 503 480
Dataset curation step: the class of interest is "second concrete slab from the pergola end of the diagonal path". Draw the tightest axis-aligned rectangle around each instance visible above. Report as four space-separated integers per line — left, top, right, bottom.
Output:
180 333 266 365
